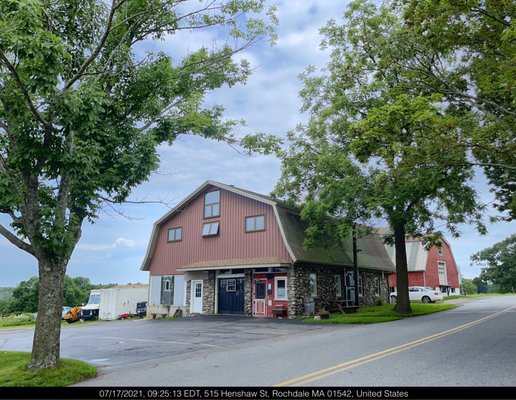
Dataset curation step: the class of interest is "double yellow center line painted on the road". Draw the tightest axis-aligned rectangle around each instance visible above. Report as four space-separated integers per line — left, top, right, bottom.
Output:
274 306 516 386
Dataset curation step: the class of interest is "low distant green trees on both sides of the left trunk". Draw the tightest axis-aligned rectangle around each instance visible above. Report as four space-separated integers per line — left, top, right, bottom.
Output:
0 275 116 315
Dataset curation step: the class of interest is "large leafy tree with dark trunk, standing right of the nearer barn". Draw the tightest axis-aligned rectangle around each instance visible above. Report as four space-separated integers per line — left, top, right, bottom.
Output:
276 1 484 313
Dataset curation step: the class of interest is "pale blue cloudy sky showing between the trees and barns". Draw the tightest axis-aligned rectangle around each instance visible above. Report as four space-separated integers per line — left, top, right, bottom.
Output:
0 0 516 287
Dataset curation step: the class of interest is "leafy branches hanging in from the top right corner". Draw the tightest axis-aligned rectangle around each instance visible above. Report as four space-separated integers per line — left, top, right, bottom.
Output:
393 0 516 219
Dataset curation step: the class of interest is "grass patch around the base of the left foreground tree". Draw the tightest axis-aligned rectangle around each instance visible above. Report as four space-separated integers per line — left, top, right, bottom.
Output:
0 351 97 387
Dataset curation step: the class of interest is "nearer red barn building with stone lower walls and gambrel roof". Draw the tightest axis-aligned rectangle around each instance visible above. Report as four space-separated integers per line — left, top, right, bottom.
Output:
141 181 394 317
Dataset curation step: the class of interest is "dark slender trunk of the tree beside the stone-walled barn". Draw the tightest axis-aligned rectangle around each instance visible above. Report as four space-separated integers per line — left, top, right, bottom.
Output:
393 223 412 314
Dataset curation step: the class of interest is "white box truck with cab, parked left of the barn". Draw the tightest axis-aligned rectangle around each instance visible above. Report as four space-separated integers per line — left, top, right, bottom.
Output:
81 284 149 320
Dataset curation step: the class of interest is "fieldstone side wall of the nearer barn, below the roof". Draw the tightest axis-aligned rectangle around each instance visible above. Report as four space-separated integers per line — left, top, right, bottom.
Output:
288 265 389 318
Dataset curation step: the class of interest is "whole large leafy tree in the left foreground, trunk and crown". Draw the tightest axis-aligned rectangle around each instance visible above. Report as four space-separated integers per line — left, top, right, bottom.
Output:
0 0 275 369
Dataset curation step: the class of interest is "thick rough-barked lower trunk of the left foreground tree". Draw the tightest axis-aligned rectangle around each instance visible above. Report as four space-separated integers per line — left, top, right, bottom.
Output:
29 260 66 370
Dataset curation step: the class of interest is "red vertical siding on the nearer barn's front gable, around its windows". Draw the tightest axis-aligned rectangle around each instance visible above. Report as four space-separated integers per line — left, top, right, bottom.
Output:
149 188 292 275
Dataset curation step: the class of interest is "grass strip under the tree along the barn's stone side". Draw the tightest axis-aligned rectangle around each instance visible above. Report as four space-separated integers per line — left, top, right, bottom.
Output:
303 303 456 324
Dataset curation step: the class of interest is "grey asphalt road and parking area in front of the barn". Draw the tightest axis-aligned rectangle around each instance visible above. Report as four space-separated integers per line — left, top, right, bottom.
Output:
0 296 516 387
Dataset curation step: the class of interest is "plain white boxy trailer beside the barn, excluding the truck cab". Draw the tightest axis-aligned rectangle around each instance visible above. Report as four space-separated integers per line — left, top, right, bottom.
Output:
99 285 149 320
